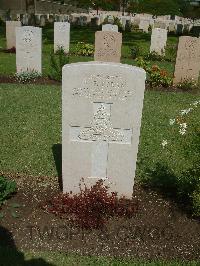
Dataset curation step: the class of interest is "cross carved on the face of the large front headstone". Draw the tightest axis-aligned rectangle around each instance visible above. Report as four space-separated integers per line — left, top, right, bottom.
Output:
70 103 132 179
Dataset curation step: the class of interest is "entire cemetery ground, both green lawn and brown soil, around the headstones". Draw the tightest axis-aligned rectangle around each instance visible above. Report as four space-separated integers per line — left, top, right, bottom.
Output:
0 24 200 265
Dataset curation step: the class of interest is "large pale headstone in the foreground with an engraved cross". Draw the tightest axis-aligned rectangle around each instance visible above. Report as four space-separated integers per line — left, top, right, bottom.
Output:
62 62 146 198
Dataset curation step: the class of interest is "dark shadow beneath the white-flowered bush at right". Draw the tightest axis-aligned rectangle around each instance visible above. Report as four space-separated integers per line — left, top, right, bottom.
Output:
142 161 200 220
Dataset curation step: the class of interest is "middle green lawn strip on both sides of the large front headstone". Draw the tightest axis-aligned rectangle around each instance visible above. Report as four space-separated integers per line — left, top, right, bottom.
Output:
0 84 200 177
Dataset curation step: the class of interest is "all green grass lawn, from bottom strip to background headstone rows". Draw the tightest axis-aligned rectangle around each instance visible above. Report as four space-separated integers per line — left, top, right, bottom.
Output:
0 24 200 266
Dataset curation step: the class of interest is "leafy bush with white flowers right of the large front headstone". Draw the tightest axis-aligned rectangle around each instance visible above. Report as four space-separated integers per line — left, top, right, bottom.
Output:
142 100 200 216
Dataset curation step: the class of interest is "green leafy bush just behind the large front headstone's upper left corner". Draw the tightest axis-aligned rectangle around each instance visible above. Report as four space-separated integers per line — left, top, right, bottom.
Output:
49 47 69 81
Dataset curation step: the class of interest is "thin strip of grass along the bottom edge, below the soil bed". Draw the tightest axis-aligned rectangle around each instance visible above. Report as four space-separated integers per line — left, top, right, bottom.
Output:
0 248 199 266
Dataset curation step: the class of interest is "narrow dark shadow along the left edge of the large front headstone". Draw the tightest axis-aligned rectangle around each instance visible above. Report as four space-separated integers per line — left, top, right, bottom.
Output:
52 143 63 190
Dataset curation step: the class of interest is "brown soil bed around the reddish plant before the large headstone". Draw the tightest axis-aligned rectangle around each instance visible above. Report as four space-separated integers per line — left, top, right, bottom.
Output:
0 176 200 260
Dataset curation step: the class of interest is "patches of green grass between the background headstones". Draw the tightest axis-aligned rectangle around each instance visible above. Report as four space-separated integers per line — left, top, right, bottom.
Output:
0 25 178 76
